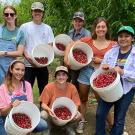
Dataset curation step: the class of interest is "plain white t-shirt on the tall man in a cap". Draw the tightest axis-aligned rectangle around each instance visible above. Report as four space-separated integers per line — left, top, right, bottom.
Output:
20 21 54 66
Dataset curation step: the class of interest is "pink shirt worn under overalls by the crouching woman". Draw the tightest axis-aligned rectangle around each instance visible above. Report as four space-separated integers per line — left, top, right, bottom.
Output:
0 81 33 109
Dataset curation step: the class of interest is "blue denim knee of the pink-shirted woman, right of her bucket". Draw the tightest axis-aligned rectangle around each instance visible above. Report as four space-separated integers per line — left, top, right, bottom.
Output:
33 118 48 132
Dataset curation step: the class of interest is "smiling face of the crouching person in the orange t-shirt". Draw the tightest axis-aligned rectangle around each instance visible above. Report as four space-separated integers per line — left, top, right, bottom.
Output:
56 71 68 84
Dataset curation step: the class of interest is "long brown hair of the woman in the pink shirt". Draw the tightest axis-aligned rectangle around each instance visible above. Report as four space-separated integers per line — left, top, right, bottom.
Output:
4 60 25 90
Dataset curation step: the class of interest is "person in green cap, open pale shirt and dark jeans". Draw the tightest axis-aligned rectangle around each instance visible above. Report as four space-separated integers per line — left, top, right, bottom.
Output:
95 26 135 135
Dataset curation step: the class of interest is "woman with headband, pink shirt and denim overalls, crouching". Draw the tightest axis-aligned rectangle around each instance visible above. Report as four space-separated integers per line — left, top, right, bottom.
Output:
0 60 47 135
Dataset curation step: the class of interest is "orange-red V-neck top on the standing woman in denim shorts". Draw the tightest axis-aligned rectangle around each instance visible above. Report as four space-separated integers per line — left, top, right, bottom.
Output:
80 37 116 59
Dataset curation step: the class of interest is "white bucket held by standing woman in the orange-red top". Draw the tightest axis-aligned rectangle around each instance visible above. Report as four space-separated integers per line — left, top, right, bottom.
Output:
68 42 93 70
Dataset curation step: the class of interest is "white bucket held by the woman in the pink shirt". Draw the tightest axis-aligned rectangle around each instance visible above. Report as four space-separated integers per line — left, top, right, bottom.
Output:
5 101 40 135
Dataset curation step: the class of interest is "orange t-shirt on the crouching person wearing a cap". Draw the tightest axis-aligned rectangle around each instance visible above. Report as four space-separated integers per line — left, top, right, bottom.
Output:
40 82 80 108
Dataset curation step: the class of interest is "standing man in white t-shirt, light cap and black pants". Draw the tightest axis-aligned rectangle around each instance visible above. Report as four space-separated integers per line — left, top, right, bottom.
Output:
20 2 54 97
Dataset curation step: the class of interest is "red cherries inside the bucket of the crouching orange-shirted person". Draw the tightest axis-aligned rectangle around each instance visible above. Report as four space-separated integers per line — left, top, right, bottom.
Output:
54 106 72 120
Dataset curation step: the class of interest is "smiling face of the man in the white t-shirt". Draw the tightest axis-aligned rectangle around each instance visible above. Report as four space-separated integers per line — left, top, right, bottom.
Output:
32 9 44 22
